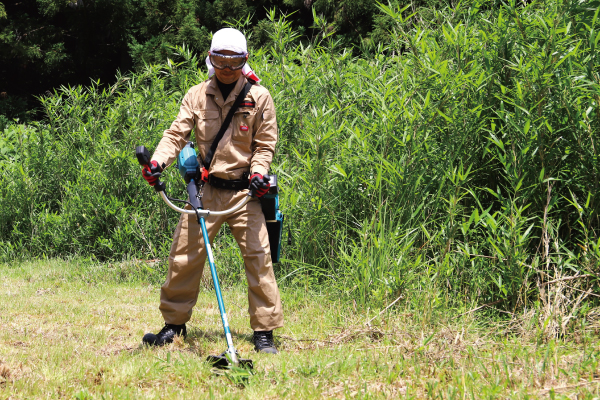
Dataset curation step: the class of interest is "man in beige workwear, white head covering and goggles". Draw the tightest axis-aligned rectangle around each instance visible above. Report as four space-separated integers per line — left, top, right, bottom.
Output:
142 28 283 354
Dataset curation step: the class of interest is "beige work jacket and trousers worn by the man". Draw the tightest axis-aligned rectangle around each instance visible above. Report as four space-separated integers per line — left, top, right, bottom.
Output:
152 76 283 331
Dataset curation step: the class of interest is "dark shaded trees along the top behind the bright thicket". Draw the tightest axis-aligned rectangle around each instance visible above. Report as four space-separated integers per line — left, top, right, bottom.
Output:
0 0 439 121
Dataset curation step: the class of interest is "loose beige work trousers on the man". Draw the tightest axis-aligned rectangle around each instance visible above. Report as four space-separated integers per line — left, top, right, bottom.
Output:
160 184 283 331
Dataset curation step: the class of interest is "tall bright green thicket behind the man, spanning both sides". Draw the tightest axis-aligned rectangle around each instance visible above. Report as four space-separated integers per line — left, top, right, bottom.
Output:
0 0 600 335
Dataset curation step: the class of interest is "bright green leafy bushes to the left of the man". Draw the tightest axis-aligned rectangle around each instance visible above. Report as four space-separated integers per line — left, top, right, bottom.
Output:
0 49 202 259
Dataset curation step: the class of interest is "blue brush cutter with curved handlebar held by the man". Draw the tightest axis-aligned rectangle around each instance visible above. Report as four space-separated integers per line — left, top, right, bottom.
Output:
135 142 254 369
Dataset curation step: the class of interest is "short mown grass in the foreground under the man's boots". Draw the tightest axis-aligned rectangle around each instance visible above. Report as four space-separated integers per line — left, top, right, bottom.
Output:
0 261 600 399
